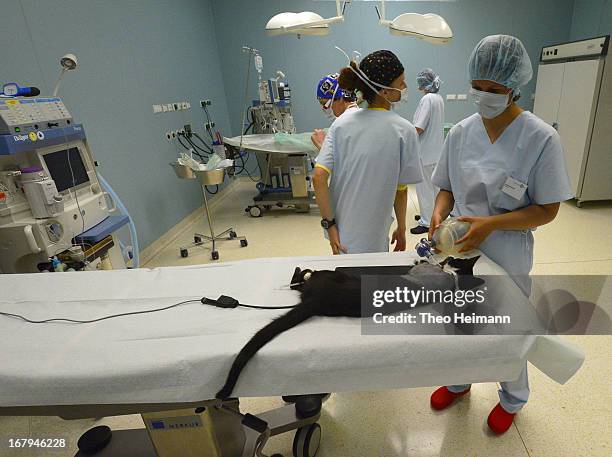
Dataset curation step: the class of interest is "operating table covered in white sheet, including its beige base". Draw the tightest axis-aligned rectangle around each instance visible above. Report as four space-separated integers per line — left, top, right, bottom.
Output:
0 253 584 457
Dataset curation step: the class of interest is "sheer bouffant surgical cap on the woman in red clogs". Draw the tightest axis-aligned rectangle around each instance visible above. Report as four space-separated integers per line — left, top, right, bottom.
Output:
468 35 533 91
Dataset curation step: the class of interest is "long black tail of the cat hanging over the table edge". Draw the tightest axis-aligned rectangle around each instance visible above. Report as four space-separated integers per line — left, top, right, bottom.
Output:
215 304 313 399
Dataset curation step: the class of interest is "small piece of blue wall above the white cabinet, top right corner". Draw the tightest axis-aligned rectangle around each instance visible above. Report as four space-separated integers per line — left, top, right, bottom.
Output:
570 0 612 41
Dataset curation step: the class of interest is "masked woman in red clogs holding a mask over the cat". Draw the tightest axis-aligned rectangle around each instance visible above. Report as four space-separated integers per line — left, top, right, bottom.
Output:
429 35 573 434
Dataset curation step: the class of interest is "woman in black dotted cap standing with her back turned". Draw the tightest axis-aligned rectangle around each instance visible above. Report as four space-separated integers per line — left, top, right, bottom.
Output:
313 50 422 254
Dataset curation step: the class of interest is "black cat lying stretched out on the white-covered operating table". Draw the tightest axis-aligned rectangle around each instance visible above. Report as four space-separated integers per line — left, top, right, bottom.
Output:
216 257 484 399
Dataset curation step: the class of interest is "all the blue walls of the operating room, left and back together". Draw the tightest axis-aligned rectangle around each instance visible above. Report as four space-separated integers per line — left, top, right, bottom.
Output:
0 0 588 253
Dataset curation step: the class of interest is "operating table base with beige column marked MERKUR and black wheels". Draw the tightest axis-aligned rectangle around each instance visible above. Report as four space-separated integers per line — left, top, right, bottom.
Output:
0 395 321 457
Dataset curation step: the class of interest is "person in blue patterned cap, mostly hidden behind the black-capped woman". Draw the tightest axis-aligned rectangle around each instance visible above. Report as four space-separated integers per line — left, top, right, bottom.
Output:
310 73 359 150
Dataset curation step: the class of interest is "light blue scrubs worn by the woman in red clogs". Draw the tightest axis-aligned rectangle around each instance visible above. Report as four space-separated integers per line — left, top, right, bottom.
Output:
432 111 574 413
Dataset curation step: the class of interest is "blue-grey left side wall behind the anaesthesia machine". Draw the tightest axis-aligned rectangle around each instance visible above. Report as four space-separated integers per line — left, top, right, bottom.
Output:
0 0 229 248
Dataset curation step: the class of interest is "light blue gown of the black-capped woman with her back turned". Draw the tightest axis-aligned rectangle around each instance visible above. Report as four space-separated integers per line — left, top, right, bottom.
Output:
316 109 422 254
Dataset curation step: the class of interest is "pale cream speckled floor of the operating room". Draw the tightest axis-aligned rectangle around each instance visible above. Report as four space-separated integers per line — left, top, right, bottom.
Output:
5 183 612 457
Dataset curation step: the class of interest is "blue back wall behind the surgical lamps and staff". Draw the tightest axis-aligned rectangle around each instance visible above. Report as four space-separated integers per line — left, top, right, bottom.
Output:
213 0 573 134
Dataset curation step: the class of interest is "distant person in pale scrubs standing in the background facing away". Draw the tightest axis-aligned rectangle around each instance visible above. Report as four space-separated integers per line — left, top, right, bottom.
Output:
410 68 444 235
